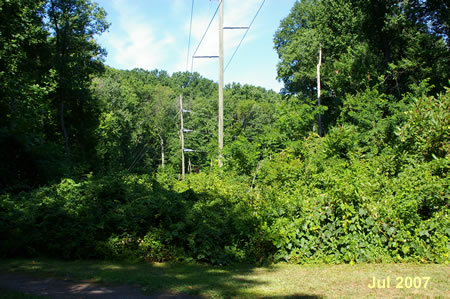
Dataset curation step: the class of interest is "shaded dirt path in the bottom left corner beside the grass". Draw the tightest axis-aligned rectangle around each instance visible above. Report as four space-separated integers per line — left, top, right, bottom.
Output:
0 273 199 299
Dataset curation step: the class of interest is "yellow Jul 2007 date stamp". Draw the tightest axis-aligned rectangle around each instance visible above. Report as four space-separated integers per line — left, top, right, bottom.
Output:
367 276 430 289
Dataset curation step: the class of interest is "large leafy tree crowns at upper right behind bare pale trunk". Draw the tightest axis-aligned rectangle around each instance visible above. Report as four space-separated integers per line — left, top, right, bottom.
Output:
274 0 450 134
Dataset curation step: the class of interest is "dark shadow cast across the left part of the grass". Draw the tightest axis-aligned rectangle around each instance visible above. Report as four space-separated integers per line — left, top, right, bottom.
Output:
0 259 320 298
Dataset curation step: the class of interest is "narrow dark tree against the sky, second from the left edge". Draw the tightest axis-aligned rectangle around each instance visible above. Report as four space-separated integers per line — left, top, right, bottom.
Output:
46 0 109 162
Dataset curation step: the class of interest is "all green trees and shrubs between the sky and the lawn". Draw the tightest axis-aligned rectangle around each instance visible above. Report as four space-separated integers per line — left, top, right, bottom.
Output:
0 0 450 264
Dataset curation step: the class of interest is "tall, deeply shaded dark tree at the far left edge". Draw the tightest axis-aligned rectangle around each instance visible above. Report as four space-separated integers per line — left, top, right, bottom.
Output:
0 0 54 191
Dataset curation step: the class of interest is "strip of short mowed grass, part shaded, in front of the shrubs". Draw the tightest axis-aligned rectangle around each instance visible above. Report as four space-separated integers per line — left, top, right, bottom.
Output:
0 259 450 298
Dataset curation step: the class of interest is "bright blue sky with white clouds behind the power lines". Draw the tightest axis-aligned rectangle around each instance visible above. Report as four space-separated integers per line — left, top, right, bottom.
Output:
94 0 295 91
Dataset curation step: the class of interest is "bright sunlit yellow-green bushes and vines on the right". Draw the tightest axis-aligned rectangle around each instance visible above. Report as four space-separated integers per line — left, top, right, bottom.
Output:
251 86 450 263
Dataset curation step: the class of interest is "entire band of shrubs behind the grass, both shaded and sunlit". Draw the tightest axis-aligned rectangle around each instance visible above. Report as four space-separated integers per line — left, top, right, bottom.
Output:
0 87 450 264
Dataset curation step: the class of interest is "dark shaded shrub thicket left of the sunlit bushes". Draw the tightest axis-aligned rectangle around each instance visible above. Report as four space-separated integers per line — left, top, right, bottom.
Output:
0 174 264 264
